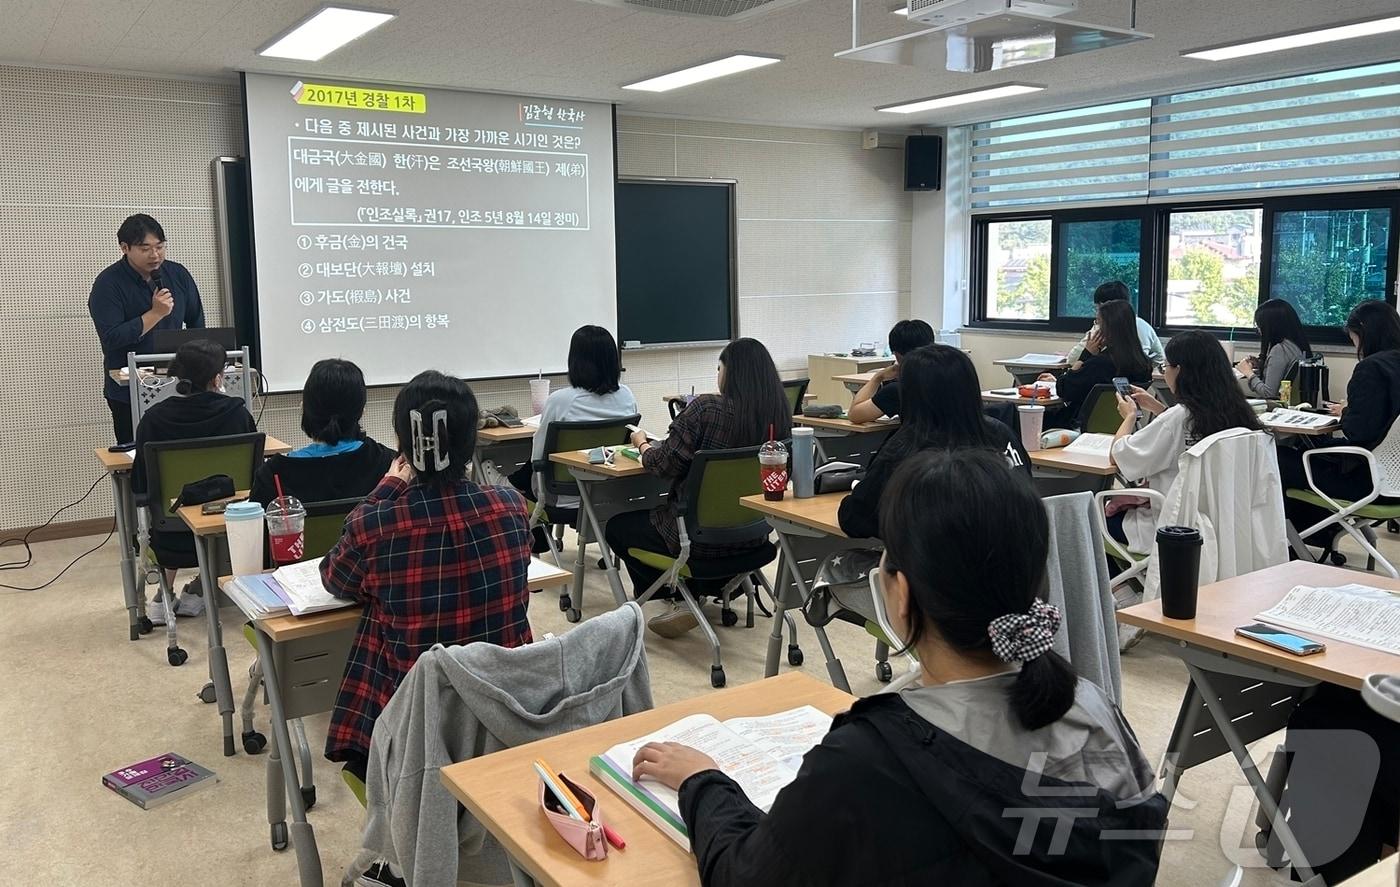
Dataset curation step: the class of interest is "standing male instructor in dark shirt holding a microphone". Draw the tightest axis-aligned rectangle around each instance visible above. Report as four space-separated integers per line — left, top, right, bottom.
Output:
88 213 204 444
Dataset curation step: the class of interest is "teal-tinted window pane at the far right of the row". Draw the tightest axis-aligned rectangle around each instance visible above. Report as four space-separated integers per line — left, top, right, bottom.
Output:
1268 201 1394 327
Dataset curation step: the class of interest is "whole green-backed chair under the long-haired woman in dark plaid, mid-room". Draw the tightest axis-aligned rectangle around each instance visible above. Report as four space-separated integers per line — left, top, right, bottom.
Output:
627 446 797 688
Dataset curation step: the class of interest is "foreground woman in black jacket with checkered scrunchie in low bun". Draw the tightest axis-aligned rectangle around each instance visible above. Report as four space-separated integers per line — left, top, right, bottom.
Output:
633 450 1168 887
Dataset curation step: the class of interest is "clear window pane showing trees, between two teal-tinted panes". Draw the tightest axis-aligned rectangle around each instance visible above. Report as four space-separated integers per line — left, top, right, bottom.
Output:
1165 207 1264 327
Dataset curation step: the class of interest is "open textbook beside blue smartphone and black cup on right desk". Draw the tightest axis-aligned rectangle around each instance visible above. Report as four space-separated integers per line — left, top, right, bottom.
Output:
1254 585 1400 655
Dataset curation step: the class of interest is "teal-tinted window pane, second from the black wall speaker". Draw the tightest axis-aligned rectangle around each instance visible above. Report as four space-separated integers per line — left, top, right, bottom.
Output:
1056 218 1142 318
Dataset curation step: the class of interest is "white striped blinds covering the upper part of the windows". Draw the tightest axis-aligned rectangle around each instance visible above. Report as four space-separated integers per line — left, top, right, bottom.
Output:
969 62 1400 213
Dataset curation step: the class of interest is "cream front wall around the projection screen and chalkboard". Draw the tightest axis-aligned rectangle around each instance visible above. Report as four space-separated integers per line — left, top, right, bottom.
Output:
0 66 913 530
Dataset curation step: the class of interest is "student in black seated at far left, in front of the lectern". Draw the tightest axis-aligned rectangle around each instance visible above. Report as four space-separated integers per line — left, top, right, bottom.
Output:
132 339 258 625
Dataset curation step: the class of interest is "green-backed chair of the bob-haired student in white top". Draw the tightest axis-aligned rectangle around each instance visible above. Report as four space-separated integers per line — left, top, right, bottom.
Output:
529 416 641 623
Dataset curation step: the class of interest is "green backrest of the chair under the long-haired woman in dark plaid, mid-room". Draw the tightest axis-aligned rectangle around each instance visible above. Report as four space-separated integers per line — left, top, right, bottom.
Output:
676 446 770 546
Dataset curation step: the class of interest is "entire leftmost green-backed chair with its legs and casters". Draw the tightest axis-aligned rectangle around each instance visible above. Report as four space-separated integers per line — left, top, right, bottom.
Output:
137 431 266 666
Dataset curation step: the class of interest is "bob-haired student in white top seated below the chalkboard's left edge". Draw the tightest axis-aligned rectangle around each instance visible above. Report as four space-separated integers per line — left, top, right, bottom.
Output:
510 326 637 545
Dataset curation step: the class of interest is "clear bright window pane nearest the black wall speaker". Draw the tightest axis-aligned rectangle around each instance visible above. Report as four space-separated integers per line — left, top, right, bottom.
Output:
983 218 1050 320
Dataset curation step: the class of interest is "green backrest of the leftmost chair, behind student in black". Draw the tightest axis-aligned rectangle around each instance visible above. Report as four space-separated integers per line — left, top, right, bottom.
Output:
141 431 267 532
